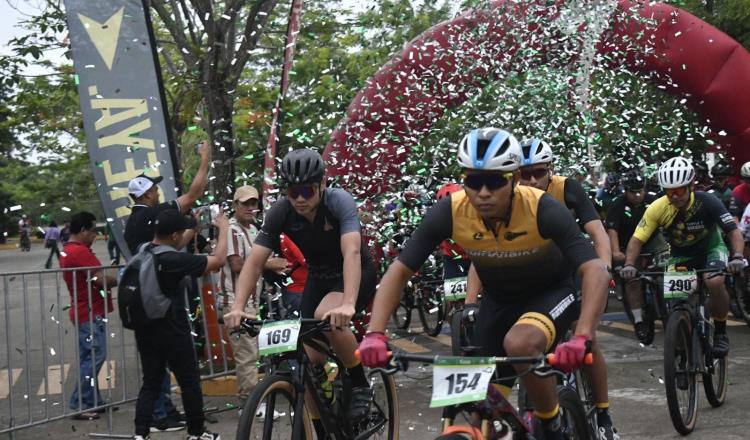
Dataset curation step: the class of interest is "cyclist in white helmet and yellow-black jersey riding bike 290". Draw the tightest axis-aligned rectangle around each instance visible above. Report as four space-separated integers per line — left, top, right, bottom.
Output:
620 157 745 357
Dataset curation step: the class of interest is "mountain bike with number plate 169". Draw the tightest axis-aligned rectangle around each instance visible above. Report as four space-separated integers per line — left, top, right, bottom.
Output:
236 319 399 440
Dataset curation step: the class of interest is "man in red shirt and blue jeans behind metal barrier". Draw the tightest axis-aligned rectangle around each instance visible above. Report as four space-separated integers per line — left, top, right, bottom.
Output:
60 212 117 420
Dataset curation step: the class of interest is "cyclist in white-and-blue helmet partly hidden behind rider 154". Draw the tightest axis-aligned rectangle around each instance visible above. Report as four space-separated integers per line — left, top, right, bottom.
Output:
516 138 619 440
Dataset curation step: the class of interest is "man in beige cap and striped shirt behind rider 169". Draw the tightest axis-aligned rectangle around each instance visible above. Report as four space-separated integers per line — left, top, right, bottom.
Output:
220 185 287 404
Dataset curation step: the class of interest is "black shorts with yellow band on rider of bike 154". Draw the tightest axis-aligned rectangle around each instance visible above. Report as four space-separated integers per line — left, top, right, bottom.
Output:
472 281 581 387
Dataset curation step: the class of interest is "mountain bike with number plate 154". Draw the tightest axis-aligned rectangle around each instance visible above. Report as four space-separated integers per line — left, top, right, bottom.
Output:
374 353 591 439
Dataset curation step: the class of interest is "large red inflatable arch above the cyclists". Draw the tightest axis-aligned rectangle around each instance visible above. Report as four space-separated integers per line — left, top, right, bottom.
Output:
324 0 750 195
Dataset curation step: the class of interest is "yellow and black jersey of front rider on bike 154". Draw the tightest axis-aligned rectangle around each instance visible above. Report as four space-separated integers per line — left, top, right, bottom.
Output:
398 185 596 300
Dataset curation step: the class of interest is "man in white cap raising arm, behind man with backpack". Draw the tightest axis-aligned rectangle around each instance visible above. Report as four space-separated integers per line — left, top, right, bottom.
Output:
125 141 211 432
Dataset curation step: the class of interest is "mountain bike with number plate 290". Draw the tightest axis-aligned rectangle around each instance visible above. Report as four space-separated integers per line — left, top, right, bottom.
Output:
641 269 732 435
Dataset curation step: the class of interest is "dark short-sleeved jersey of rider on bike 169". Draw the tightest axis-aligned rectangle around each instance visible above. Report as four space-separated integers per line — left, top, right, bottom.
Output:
255 188 372 276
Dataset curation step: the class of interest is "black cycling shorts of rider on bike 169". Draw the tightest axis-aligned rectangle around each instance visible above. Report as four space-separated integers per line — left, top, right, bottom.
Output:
301 265 377 318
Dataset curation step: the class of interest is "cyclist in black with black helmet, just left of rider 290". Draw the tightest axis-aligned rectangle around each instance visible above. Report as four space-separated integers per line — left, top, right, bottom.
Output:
605 170 667 345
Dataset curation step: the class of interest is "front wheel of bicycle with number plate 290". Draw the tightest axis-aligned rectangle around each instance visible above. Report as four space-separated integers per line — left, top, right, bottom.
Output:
664 311 698 435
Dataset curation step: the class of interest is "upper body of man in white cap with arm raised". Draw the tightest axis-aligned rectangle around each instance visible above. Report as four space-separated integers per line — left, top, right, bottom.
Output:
125 141 211 255
